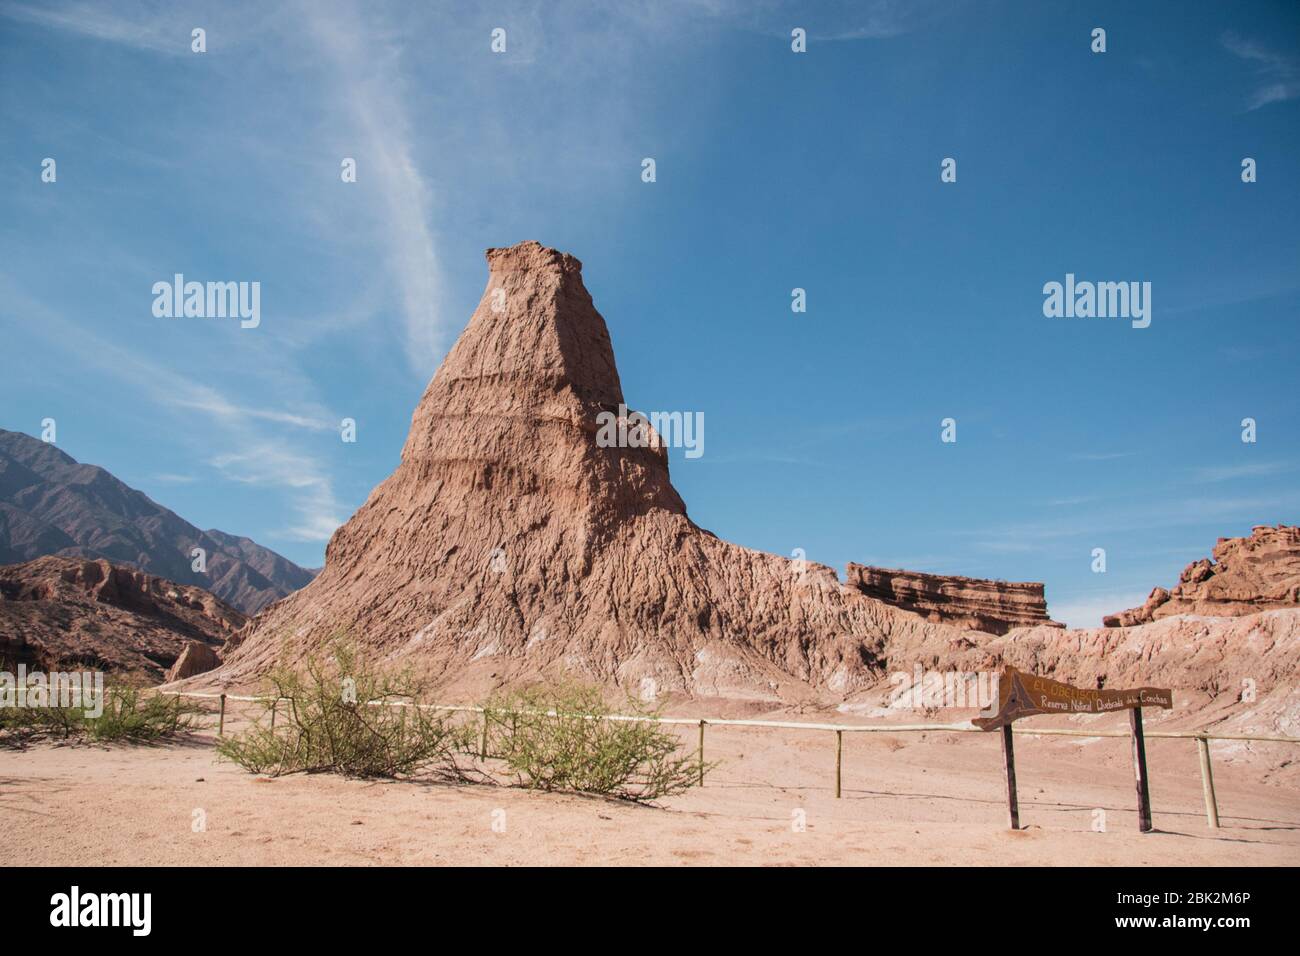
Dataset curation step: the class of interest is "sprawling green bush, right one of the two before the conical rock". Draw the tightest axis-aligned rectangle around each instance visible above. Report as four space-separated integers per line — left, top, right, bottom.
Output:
485 684 714 801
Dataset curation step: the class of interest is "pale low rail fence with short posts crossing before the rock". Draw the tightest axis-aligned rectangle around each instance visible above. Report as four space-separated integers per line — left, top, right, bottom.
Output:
159 691 1300 830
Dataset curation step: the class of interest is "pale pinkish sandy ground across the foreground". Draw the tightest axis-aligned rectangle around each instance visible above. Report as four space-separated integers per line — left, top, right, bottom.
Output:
0 715 1300 866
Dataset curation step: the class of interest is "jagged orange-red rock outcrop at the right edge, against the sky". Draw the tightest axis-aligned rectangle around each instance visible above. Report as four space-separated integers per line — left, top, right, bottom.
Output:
1101 524 1300 627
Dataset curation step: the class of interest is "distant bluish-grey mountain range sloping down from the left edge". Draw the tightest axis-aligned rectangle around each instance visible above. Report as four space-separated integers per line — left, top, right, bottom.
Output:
0 429 316 614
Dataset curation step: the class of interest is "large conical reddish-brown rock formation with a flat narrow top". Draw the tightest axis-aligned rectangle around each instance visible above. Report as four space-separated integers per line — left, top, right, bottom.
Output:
216 242 957 698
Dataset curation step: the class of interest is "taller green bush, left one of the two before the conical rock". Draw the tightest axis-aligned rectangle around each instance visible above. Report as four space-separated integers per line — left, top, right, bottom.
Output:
217 641 472 777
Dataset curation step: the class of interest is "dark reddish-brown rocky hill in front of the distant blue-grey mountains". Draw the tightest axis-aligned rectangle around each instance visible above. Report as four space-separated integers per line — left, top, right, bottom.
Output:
0 557 246 679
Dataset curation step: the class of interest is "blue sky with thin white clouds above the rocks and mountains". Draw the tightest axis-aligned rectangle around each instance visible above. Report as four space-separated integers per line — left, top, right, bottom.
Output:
0 0 1300 626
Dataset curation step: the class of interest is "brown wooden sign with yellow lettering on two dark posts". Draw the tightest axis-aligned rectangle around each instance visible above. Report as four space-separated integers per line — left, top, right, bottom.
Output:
971 666 1174 832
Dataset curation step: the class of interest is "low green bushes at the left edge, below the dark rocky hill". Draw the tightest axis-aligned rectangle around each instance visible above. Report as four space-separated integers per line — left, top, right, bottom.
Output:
0 687 203 747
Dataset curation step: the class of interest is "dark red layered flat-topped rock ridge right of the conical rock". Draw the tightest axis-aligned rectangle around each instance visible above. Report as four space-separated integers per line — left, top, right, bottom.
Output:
845 563 1065 635
